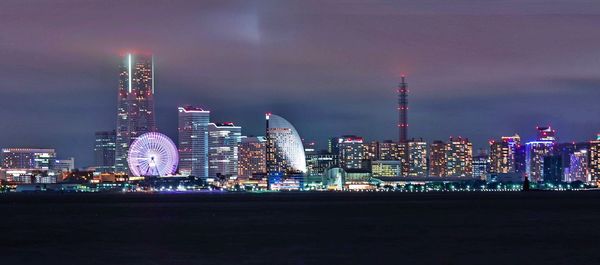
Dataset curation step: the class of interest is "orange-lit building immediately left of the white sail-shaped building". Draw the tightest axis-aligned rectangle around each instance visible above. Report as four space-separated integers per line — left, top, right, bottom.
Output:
238 136 267 179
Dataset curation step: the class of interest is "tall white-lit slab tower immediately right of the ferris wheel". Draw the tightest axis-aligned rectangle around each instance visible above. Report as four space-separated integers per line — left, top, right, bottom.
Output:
178 106 210 178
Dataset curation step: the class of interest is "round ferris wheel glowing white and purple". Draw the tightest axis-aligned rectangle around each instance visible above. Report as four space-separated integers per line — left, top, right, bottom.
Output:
127 132 179 177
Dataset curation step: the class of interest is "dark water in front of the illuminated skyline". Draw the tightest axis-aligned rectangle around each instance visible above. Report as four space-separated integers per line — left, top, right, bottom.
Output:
0 192 600 264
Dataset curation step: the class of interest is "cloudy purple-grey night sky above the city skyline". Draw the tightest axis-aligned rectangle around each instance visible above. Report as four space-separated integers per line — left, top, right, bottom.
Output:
0 0 600 167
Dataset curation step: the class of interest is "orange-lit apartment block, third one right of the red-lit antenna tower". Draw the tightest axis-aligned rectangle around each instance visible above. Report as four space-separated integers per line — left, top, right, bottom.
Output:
446 137 473 177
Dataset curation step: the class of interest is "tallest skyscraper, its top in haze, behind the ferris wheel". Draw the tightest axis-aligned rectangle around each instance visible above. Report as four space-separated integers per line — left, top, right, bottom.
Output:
115 54 156 173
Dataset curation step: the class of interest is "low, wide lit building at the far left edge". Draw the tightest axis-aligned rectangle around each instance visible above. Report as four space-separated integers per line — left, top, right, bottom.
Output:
1 148 56 170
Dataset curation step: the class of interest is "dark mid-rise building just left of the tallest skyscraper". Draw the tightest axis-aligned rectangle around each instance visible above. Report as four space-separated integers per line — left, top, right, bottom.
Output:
94 130 116 173
